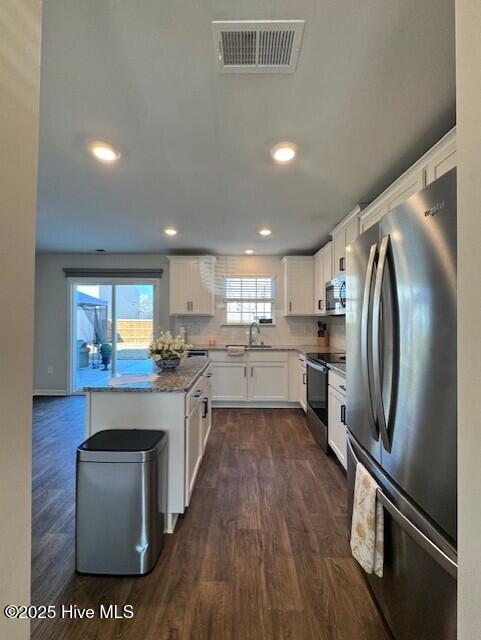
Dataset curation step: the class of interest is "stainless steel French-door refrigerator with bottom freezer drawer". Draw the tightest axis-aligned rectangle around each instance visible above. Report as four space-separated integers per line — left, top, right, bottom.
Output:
346 169 457 640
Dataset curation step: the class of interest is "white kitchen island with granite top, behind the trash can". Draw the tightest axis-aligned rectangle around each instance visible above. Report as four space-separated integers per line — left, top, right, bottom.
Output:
84 357 212 533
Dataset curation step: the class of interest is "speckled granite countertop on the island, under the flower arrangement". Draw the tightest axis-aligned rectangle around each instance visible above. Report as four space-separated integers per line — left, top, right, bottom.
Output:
84 356 210 393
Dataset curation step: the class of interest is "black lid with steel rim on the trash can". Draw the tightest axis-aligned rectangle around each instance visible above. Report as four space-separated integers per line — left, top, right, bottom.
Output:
77 429 167 462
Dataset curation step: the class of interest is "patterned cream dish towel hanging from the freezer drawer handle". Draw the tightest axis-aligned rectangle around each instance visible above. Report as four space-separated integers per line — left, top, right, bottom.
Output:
351 462 384 578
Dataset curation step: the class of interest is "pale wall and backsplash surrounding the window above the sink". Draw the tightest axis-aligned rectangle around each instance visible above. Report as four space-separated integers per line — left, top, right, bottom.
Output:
170 256 317 345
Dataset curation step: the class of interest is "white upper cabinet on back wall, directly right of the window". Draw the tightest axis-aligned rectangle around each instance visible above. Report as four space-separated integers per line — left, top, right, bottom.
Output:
282 256 314 316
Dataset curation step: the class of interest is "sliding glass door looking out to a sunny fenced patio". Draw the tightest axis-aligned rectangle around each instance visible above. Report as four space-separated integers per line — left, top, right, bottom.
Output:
70 280 158 393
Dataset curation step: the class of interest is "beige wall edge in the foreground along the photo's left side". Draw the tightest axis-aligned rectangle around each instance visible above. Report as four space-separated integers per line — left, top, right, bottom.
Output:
0 0 41 640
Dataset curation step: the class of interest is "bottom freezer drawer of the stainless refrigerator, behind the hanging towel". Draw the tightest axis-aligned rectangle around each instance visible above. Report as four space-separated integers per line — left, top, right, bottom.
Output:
348 444 457 640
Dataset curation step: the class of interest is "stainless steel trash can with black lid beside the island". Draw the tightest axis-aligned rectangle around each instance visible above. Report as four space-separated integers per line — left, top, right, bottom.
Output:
76 429 168 575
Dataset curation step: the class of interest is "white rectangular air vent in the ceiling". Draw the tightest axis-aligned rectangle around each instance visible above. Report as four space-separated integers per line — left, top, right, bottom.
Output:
212 20 305 73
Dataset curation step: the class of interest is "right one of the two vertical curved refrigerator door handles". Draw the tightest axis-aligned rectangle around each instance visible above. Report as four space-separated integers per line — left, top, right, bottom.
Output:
372 235 397 451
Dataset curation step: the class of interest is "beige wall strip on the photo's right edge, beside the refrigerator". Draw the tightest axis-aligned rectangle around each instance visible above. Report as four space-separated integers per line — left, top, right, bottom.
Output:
456 0 481 640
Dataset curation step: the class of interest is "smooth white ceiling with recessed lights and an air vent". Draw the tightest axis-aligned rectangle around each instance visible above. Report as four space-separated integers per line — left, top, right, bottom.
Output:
37 0 455 254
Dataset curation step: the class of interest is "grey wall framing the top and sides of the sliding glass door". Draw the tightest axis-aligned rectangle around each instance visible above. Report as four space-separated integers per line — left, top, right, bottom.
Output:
34 253 169 393
